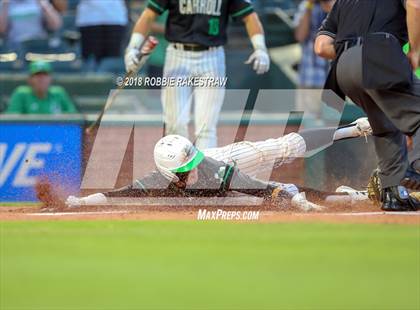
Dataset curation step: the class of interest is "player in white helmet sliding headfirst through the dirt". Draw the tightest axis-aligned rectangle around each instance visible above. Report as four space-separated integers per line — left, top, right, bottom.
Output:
66 118 415 211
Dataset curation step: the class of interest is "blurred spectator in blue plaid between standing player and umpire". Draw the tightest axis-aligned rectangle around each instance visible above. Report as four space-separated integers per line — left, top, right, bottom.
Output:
294 0 335 116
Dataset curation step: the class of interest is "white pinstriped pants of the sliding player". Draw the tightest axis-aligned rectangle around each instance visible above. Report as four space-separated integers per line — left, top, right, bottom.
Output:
203 133 306 194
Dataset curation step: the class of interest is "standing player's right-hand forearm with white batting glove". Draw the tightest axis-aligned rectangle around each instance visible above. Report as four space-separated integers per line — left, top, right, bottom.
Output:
243 13 270 74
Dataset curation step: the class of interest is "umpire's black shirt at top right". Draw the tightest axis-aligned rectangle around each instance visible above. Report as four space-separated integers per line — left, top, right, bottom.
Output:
318 0 408 45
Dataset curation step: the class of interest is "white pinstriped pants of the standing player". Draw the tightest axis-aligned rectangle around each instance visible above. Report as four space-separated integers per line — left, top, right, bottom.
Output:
162 44 226 149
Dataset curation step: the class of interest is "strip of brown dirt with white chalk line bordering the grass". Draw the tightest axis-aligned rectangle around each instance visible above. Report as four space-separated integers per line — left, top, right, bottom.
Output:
0 205 420 225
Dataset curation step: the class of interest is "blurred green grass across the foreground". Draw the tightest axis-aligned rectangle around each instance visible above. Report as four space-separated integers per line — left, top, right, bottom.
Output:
0 221 420 310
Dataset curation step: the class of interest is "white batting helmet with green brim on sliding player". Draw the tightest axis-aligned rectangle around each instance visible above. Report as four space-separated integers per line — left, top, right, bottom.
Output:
154 135 204 182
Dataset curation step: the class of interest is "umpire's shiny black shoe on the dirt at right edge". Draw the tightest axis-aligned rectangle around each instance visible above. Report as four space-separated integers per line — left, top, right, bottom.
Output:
381 186 420 212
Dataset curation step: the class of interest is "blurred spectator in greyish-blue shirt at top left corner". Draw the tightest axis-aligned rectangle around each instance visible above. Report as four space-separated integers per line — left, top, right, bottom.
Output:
0 0 62 48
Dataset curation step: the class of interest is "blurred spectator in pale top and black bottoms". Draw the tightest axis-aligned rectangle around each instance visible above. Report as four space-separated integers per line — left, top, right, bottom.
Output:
76 0 128 63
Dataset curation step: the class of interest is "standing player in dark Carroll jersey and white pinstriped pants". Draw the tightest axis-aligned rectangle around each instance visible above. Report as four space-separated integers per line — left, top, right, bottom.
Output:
125 0 270 148
